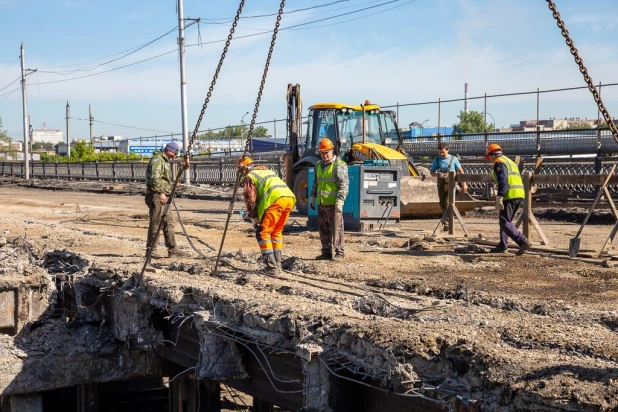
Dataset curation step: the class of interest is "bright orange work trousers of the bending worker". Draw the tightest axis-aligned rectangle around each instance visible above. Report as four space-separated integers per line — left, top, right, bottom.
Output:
256 197 296 255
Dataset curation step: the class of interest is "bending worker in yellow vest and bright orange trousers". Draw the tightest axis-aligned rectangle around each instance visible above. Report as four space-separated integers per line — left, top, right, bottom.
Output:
236 157 296 275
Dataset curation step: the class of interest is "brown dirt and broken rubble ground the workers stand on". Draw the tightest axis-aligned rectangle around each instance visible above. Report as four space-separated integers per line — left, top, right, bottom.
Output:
0 184 618 411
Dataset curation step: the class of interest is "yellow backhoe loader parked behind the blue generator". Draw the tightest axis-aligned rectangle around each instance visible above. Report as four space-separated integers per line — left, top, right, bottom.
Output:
285 84 476 217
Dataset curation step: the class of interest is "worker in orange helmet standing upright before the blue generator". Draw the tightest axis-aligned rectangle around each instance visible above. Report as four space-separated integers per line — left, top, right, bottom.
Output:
309 139 349 260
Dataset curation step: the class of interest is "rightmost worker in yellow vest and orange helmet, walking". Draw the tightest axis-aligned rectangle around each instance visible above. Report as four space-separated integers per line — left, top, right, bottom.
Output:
485 143 530 256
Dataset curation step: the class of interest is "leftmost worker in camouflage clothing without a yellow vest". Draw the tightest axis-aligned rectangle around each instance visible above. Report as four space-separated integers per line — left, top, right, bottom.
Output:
145 142 189 259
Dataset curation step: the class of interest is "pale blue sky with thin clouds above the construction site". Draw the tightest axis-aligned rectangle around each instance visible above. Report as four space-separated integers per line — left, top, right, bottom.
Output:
0 0 618 140
